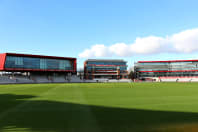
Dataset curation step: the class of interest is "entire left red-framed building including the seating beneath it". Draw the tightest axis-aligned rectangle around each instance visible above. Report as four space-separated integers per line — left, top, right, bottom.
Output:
0 53 77 82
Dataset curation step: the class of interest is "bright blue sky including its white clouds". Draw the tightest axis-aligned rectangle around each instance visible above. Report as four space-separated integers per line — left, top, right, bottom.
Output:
0 0 198 67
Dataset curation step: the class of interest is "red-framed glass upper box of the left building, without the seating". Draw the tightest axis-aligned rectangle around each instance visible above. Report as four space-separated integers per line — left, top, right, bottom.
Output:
0 53 76 73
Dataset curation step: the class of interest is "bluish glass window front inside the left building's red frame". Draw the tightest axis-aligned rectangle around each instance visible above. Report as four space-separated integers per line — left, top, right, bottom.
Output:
5 56 74 70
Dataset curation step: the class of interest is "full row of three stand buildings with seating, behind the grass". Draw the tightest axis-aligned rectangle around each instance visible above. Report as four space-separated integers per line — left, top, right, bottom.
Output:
0 53 198 84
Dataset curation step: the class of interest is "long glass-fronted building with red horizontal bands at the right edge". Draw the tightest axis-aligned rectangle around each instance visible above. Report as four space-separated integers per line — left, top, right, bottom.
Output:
134 60 198 79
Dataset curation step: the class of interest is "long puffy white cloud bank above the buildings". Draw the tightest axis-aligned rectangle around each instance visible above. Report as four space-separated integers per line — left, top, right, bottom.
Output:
79 28 198 58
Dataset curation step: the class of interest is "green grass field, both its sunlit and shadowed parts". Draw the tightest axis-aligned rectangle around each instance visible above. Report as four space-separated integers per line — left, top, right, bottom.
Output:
0 83 198 132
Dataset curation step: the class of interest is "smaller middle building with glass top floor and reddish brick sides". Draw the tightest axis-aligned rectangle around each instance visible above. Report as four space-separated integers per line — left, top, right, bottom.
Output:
84 59 128 80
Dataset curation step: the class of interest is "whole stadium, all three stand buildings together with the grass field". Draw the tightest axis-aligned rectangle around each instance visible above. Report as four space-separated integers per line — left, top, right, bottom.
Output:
0 53 198 132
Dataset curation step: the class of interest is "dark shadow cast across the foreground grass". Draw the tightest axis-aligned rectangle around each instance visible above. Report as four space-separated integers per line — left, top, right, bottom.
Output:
0 94 198 132
